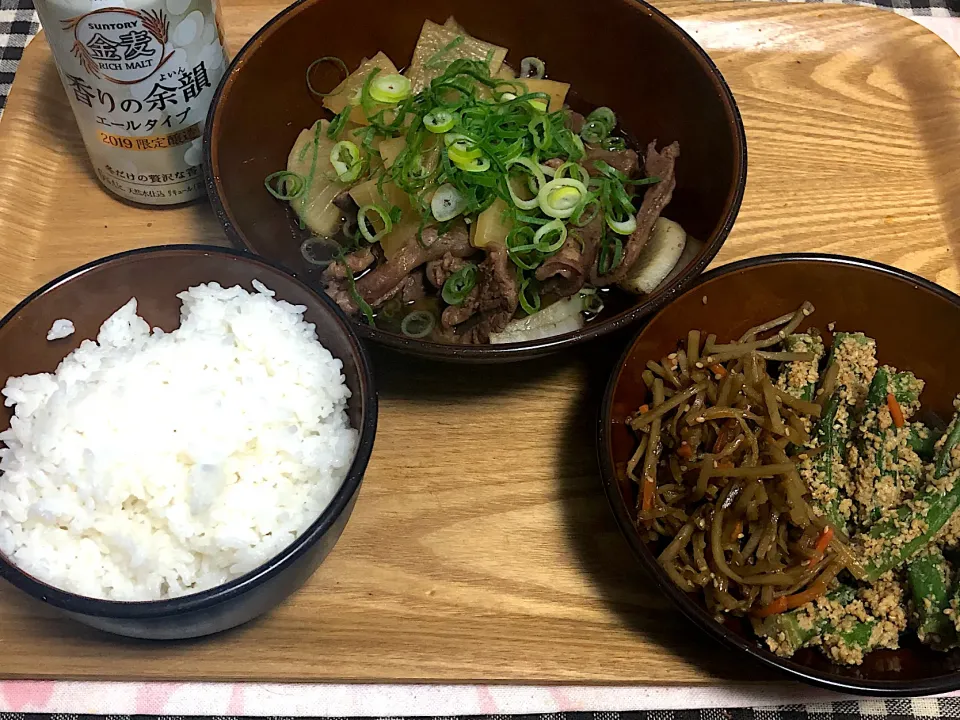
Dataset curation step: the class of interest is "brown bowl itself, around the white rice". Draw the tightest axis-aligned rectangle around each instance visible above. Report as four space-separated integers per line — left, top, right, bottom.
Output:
0 245 377 640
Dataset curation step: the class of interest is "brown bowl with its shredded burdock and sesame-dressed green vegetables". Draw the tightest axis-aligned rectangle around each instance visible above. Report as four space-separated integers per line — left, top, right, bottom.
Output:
598 254 960 696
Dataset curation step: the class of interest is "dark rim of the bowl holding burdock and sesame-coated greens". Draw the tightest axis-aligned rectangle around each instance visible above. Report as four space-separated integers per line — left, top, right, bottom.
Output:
597 253 960 697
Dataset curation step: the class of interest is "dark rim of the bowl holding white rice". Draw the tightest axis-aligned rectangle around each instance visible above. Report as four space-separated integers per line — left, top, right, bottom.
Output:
0 244 378 620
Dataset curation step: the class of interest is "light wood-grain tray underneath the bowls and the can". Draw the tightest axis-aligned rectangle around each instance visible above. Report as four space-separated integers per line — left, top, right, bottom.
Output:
0 0 960 684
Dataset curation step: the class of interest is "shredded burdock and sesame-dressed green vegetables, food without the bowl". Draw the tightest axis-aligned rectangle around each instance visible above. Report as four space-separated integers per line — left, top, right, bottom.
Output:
626 303 960 665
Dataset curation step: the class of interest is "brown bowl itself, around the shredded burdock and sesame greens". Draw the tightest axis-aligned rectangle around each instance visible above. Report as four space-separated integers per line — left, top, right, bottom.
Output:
598 254 960 695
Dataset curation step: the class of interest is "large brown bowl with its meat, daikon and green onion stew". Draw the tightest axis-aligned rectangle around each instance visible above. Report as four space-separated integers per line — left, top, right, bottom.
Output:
204 0 746 362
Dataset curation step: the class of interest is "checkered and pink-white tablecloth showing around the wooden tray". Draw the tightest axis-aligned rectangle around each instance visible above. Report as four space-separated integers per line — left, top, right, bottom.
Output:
0 0 960 720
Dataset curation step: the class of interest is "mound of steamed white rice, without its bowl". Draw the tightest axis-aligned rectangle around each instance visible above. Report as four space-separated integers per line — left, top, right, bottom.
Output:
0 281 358 600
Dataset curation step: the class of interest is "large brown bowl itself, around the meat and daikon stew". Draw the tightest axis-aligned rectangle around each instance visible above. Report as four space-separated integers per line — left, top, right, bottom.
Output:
204 0 747 362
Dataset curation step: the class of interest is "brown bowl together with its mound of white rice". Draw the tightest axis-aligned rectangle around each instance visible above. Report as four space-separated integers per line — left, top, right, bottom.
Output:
0 245 377 639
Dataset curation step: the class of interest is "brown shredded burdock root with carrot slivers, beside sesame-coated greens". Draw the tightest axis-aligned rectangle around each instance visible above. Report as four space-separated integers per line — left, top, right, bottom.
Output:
627 303 855 614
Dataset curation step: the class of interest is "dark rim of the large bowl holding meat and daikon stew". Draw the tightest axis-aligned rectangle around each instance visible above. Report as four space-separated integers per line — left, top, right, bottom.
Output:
203 0 747 362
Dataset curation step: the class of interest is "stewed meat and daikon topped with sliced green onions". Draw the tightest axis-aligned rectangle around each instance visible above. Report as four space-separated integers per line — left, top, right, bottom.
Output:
265 18 703 344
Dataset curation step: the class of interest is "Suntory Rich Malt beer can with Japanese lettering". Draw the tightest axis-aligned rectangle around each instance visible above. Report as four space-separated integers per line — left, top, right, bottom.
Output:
34 0 227 205
